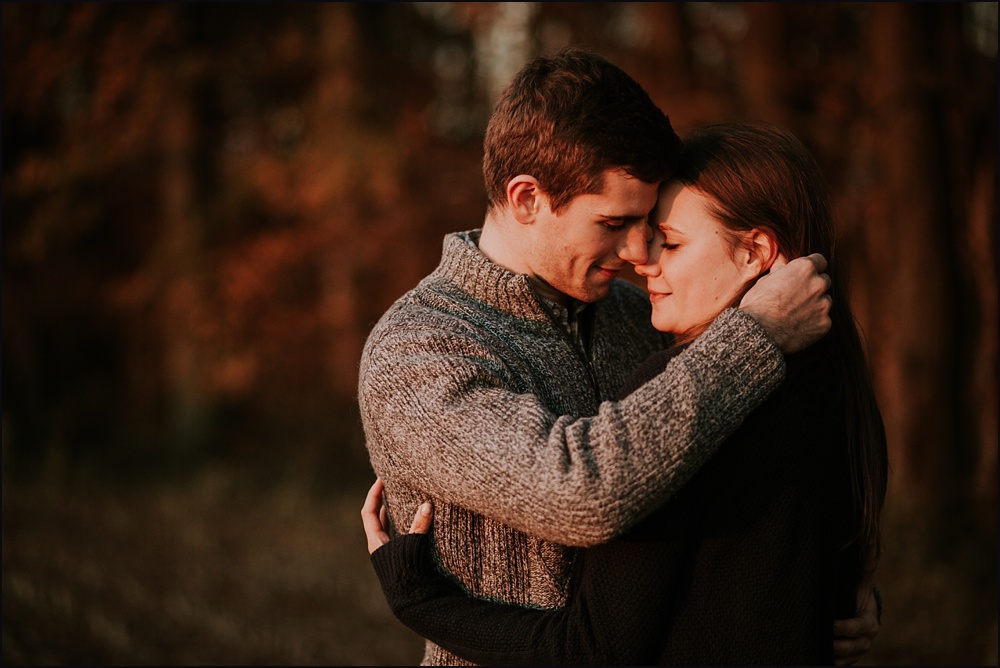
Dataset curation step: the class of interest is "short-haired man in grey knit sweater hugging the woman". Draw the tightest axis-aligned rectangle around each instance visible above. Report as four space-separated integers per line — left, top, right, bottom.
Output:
358 50 876 665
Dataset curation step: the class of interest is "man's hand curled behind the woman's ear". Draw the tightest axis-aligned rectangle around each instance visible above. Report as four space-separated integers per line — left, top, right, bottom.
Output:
740 253 833 355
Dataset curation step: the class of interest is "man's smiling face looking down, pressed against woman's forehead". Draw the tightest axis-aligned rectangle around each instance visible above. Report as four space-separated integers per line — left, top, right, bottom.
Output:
528 170 658 302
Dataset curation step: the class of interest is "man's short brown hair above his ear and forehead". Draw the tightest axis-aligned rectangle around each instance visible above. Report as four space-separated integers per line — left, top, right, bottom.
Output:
483 48 681 211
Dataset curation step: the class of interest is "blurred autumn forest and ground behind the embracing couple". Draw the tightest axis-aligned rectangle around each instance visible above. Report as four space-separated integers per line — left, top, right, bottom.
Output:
2 2 998 665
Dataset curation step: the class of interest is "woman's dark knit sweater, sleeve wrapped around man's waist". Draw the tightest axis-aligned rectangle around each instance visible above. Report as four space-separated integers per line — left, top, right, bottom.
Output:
372 342 860 665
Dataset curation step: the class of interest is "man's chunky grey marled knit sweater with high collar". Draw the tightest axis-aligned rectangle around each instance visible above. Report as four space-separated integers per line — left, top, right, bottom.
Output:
358 230 785 665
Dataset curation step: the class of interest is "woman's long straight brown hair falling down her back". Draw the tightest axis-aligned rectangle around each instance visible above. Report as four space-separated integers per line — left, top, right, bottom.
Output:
673 123 888 562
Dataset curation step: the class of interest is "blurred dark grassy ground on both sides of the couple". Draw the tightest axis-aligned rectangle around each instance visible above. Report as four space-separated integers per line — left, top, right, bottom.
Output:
2 471 997 665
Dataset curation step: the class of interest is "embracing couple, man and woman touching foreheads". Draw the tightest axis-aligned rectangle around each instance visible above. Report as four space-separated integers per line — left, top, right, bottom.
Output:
358 49 887 665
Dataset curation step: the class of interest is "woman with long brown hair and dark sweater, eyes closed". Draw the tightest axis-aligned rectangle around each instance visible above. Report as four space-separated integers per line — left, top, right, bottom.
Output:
363 124 887 665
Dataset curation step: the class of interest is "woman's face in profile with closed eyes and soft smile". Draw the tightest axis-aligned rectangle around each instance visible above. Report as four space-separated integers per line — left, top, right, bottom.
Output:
636 181 756 338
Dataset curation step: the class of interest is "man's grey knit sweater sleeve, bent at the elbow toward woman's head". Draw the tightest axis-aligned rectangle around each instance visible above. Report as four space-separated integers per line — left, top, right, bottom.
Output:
358 309 784 546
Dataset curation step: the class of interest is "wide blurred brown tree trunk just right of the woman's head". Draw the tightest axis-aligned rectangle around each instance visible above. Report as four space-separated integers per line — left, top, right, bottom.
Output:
861 3 962 502
